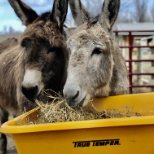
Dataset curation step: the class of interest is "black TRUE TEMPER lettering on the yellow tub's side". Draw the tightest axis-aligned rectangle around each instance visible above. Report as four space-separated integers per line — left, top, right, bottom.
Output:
73 139 120 148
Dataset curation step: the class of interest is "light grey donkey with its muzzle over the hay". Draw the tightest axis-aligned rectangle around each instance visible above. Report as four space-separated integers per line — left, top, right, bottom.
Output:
63 0 129 107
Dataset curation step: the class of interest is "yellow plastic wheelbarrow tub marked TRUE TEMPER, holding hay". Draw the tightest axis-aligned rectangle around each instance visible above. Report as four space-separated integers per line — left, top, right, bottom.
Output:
0 93 154 154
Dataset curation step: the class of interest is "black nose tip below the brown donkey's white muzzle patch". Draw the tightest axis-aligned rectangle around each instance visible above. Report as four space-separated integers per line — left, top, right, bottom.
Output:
21 86 38 100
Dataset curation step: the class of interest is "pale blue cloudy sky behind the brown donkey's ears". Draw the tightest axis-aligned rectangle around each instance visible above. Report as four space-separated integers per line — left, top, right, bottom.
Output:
0 0 154 32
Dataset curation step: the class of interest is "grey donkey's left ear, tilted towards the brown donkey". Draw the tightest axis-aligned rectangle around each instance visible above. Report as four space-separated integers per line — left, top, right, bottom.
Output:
69 0 92 26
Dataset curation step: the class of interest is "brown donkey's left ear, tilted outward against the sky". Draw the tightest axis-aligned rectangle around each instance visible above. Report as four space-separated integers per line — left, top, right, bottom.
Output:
9 0 38 26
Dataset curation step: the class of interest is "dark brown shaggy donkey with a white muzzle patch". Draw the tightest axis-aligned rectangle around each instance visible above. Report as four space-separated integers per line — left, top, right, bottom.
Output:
0 0 68 154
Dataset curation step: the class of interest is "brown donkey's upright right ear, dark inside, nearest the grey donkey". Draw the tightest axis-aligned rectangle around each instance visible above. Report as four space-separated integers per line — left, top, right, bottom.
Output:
51 0 68 30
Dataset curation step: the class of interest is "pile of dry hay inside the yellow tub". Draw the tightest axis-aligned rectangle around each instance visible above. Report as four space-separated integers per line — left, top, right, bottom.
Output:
22 91 140 124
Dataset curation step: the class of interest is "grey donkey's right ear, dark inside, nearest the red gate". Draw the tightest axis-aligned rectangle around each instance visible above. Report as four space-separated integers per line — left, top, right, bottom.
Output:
99 0 120 30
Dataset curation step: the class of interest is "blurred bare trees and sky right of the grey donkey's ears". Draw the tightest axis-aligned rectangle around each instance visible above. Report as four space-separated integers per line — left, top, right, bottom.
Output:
118 0 154 22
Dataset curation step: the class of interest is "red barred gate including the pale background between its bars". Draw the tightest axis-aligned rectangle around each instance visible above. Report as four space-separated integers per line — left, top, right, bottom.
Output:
114 30 154 93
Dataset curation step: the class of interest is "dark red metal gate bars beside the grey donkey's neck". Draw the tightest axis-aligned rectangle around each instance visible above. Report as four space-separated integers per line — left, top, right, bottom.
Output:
114 30 154 93
